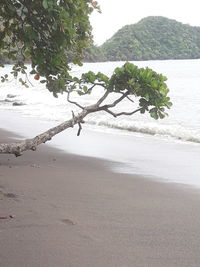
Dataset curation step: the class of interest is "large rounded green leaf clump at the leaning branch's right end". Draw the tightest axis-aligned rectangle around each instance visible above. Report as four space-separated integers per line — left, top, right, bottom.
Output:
109 62 172 119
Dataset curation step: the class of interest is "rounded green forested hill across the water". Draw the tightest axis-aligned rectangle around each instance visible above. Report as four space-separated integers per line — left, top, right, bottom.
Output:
86 17 200 61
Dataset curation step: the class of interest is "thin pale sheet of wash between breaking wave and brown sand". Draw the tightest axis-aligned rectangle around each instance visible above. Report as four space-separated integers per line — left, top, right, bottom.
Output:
0 110 200 189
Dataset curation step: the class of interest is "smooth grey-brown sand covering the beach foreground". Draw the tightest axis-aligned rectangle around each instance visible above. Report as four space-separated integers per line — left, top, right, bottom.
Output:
0 130 200 267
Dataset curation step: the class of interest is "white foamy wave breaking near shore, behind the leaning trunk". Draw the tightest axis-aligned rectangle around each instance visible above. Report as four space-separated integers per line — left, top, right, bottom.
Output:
0 96 200 147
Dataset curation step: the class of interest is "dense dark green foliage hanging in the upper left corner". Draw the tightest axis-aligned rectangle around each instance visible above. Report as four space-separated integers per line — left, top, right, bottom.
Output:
0 0 98 92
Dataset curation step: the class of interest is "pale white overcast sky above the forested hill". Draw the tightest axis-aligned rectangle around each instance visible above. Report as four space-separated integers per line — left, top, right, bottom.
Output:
90 0 200 45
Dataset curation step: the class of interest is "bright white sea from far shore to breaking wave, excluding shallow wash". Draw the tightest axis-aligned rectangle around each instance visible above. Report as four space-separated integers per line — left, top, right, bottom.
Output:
0 59 200 146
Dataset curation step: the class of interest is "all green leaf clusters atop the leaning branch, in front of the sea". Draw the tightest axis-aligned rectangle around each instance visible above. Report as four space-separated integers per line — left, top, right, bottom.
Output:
73 62 172 119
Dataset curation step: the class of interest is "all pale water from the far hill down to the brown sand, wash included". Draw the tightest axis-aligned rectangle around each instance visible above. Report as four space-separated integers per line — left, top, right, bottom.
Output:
0 60 200 188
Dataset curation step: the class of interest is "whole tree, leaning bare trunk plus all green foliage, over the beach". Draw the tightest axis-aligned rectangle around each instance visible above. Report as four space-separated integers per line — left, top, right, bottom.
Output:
0 0 172 156
